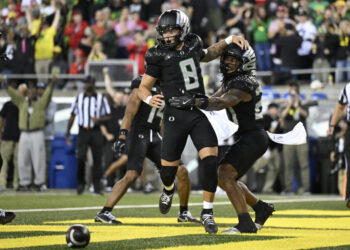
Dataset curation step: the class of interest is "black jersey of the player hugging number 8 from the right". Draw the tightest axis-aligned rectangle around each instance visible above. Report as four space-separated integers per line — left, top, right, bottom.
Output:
223 74 264 133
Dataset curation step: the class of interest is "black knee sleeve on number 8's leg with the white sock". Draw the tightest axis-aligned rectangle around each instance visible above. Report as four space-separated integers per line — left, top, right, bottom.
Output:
202 156 218 192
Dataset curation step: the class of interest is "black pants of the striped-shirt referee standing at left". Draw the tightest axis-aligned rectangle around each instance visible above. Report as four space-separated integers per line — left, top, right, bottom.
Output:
77 128 103 193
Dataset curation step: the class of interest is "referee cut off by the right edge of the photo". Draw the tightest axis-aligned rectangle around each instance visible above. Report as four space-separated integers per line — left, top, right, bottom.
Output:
327 82 350 208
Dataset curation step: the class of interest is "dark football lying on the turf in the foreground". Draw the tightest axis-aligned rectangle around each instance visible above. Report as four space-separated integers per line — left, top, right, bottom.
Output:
66 224 90 248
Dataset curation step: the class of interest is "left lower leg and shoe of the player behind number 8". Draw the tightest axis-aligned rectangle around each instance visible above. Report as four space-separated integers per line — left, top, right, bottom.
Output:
95 170 139 224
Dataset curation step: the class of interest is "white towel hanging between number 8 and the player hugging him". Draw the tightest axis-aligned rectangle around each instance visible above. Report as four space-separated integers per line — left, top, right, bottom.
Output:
199 109 238 141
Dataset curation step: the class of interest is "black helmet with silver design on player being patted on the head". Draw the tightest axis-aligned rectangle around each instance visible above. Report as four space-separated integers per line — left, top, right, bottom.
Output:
220 43 256 77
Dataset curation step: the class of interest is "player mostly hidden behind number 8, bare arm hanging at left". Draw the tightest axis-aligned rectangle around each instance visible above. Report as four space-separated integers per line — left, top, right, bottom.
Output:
95 68 199 224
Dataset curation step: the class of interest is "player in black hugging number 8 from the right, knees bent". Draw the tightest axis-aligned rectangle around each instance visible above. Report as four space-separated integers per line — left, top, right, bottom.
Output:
169 44 274 234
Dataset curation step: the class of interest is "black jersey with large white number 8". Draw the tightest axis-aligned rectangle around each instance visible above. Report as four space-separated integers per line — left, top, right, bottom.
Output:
146 33 205 104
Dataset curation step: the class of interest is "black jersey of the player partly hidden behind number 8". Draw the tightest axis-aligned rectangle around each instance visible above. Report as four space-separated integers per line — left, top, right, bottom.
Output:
131 76 163 131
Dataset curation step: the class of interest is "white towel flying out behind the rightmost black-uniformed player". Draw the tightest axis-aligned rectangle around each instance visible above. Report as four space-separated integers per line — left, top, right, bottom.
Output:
266 122 307 145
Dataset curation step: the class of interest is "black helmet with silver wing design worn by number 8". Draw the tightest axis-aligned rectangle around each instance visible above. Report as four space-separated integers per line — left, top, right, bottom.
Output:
157 9 190 49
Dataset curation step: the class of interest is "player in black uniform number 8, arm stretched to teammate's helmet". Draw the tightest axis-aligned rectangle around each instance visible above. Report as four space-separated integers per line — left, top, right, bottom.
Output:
139 10 249 233
